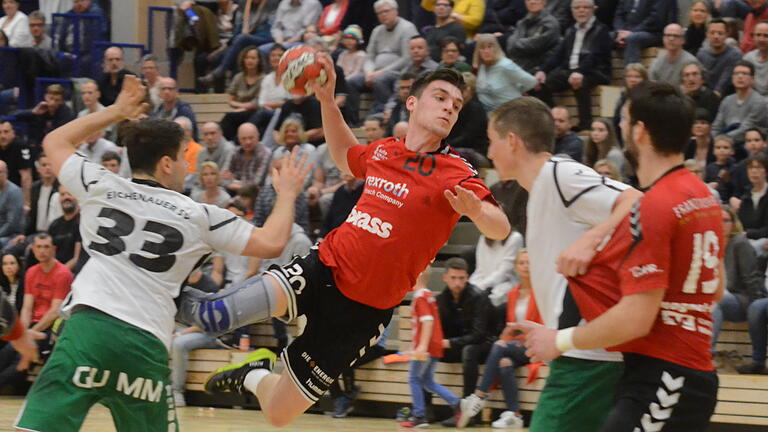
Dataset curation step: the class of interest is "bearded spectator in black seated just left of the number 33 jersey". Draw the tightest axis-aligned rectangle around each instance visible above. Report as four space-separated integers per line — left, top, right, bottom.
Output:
48 185 84 273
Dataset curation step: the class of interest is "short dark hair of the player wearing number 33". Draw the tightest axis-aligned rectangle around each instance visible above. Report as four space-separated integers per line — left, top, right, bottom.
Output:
120 118 184 174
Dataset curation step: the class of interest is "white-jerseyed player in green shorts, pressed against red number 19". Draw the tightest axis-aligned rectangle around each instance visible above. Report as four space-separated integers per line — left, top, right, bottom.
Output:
480 97 641 432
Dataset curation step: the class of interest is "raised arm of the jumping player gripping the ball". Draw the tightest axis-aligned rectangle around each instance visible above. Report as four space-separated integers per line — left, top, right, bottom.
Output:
312 54 358 174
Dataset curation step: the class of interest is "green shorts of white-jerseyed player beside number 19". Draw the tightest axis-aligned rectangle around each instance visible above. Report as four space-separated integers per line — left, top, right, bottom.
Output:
530 357 624 432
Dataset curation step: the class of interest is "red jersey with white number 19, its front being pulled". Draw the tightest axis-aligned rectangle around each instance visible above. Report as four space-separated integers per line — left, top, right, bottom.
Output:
569 166 725 371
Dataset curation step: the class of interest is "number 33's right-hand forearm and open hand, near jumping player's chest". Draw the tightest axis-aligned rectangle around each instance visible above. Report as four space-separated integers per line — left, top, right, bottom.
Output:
242 146 312 258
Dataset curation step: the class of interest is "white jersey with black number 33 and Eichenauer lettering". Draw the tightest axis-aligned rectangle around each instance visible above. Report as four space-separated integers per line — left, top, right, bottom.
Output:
59 153 253 346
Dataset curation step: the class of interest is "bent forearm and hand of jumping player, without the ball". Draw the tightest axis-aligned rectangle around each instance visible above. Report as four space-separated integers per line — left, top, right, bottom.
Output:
444 186 512 240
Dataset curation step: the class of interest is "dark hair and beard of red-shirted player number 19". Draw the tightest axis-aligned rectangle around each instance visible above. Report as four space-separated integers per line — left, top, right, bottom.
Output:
627 81 696 155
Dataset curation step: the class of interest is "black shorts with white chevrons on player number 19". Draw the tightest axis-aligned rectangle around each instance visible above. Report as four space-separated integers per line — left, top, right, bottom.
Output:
602 353 718 432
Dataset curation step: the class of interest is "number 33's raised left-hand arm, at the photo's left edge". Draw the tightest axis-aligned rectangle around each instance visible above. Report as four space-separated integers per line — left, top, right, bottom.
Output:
43 75 148 176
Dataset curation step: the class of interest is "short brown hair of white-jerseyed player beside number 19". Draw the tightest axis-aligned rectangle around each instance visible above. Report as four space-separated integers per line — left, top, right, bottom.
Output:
491 96 555 153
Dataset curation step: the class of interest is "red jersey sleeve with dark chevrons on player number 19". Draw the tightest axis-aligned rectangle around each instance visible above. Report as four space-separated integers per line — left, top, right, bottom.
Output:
619 199 677 295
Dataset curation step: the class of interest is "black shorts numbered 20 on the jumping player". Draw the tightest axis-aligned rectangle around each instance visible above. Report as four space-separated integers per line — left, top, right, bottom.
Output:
267 248 394 402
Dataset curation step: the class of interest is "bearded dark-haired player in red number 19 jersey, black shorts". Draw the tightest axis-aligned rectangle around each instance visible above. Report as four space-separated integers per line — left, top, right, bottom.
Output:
519 82 725 432
